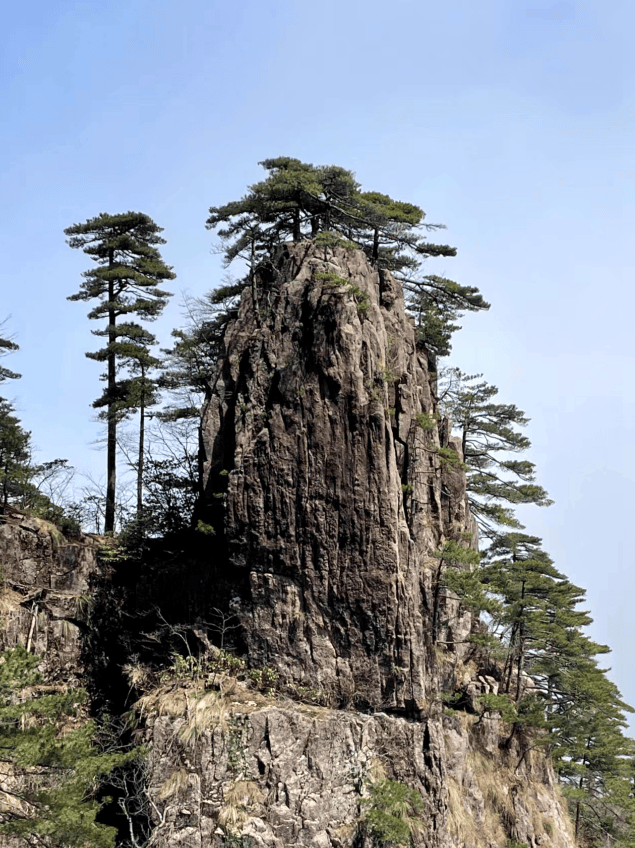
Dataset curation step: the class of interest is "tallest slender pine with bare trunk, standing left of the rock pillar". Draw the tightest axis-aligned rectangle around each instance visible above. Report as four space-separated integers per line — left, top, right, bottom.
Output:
64 212 176 533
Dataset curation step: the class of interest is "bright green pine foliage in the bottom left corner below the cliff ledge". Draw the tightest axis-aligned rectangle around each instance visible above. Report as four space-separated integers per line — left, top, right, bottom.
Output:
0 648 139 848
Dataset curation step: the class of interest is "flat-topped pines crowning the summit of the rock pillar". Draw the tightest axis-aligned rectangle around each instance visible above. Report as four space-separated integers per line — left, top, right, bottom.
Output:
206 156 489 356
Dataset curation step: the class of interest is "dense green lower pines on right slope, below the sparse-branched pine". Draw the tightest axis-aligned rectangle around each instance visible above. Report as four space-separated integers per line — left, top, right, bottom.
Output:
445 532 635 848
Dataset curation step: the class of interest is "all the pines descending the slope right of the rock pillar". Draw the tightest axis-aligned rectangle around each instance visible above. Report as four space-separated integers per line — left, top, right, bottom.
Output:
437 368 635 846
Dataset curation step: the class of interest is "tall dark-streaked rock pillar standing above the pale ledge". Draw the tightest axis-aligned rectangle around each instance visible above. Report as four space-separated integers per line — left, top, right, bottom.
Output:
202 242 475 713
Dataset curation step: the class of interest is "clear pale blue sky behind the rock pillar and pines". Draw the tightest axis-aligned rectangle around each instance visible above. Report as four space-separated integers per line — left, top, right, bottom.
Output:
0 0 635 703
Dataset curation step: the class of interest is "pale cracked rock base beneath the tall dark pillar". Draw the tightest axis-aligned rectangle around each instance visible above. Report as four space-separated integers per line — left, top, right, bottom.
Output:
140 685 573 848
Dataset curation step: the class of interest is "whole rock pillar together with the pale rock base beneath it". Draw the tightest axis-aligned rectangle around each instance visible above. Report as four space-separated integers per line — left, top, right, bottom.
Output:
142 242 573 848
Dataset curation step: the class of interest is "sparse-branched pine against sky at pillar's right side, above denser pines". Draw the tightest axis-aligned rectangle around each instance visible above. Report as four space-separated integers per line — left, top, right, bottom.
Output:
439 368 553 537
